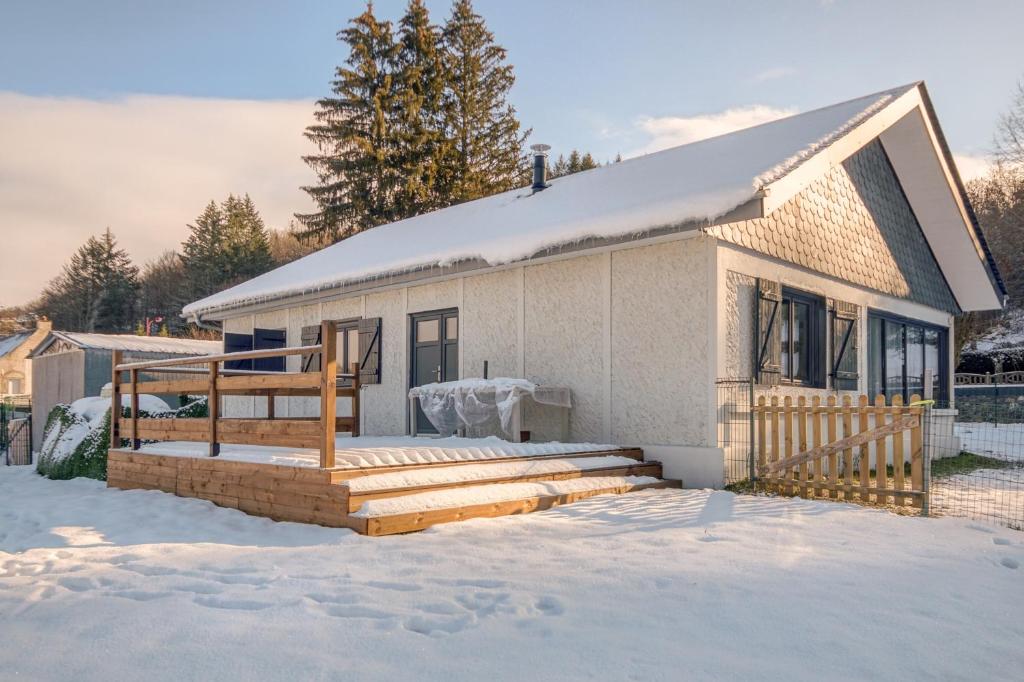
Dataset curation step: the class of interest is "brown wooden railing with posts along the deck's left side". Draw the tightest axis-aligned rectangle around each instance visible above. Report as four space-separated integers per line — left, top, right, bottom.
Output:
111 321 359 469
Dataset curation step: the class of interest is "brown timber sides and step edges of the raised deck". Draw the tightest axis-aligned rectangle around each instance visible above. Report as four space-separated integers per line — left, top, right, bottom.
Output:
106 449 680 536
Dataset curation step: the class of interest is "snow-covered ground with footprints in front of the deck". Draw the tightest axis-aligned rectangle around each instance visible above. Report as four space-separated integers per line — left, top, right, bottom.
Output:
0 467 1024 682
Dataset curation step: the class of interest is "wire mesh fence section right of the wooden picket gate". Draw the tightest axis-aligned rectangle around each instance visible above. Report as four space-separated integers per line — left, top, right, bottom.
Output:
926 384 1024 530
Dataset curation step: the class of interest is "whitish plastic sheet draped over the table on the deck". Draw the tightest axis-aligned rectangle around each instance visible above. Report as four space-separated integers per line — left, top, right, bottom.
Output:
409 377 572 436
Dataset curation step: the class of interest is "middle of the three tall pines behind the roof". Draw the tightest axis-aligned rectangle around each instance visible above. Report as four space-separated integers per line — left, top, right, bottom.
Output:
395 0 447 218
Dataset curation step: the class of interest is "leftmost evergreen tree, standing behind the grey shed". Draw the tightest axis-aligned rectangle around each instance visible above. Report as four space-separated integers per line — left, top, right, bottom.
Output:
39 228 138 333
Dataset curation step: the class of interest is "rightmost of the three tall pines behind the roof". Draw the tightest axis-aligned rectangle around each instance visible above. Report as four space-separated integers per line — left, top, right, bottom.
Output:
441 0 530 204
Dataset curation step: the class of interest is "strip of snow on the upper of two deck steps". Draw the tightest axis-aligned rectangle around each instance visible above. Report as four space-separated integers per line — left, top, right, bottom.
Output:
345 455 637 493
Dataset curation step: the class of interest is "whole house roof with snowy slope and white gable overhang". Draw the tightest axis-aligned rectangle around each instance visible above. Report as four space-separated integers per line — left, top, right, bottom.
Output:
183 83 1005 319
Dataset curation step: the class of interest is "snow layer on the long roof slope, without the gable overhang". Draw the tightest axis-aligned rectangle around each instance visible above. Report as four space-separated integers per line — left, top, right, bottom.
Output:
183 84 999 317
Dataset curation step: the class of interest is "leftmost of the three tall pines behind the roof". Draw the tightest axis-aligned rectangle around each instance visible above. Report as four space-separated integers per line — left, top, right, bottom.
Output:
296 4 402 242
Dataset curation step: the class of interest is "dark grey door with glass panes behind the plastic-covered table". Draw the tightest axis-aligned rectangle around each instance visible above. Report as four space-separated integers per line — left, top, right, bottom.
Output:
410 309 459 433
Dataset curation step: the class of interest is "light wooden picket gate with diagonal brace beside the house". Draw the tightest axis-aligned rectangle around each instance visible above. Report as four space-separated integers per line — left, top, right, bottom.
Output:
754 395 928 510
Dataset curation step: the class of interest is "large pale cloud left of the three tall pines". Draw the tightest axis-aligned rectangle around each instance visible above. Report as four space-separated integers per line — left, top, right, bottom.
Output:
0 92 313 305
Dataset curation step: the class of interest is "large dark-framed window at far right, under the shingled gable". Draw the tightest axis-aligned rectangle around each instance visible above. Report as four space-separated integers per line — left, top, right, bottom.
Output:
867 311 949 400
